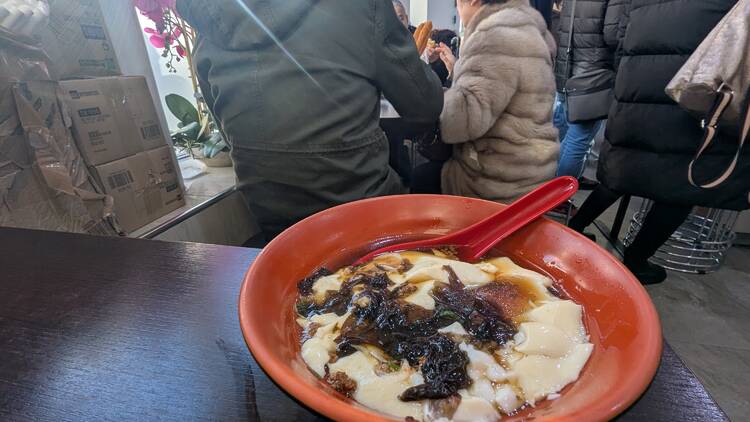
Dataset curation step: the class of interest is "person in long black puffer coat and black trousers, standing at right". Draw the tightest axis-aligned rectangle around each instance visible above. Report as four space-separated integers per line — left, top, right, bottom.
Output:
570 0 750 284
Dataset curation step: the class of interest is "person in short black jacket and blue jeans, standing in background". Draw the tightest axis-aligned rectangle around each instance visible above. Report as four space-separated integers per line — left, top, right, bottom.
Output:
555 0 627 178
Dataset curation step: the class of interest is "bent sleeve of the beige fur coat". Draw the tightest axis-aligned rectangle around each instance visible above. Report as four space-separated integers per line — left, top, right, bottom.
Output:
440 34 519 144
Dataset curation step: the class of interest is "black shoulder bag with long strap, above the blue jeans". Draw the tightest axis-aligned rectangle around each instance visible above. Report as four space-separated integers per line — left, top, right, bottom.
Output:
563 0 615 123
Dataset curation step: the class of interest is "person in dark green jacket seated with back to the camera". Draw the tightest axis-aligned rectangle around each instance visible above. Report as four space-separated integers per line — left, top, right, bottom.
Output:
177 0 443 238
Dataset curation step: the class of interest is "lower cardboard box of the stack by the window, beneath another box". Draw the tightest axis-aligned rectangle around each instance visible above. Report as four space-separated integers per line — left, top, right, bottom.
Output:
93 147 185 233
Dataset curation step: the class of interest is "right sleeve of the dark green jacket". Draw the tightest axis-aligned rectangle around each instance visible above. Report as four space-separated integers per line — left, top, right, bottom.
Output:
374 0 443 123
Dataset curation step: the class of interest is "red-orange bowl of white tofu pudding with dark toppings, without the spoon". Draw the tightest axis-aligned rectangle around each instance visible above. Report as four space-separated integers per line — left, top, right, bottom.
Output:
239 195 662 422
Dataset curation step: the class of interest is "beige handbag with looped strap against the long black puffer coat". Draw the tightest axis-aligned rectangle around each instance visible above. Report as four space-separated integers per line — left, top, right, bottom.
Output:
666 0 750 189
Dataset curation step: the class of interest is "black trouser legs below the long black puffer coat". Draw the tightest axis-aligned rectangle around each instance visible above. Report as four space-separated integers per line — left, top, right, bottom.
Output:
569 184 693 262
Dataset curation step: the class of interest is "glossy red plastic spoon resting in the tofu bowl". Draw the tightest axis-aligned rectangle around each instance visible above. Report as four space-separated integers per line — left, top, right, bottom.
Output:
354 176 578 265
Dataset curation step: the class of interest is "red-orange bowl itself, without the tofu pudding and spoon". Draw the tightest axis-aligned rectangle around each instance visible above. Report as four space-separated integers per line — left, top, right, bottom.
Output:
239 195 662 421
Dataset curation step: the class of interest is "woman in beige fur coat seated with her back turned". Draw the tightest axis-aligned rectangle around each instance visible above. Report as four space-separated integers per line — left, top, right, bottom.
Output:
413 0 559 203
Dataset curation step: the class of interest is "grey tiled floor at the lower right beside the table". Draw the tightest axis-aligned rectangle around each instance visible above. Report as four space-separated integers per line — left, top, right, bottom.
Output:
576 194 750 422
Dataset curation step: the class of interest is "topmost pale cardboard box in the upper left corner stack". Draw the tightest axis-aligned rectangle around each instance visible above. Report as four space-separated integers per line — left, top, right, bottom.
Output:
39 0 120 79
